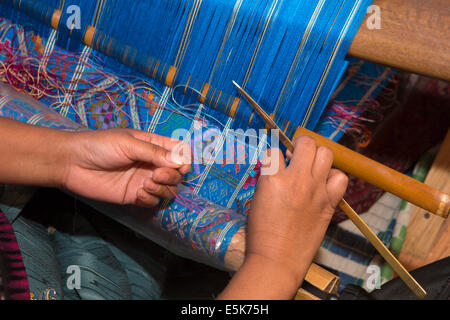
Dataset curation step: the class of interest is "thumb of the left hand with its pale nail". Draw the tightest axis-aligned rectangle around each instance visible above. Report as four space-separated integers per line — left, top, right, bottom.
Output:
127 139 183 169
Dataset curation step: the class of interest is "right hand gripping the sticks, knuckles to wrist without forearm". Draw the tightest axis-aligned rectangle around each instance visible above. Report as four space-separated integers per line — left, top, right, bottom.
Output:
247 137 348 284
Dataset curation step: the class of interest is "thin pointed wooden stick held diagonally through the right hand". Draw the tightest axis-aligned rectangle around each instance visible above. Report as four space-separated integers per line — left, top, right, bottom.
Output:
233 82 426 299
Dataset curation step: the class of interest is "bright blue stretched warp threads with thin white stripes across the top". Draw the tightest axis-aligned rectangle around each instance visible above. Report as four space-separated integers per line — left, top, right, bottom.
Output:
0 0 371 137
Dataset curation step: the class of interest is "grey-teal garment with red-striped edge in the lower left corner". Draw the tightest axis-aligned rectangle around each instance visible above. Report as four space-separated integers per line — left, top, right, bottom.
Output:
0 187 169 300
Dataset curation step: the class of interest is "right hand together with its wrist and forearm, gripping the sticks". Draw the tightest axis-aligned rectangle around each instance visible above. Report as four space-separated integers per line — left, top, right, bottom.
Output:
220 137 348 299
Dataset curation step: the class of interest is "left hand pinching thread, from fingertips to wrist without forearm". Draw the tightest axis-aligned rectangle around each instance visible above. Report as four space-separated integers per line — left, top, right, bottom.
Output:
62 129 191 207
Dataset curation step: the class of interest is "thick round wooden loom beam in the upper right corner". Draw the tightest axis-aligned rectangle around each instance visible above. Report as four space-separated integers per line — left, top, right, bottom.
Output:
348 0 450 81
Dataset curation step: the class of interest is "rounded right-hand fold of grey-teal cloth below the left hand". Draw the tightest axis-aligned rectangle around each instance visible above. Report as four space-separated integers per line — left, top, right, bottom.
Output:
49 214 162 300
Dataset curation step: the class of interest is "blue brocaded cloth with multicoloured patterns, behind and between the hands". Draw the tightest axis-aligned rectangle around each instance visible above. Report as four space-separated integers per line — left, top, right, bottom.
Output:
0 20 267 264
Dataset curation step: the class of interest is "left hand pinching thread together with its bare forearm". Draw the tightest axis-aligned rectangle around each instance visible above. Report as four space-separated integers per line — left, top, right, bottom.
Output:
0 117 191 207
